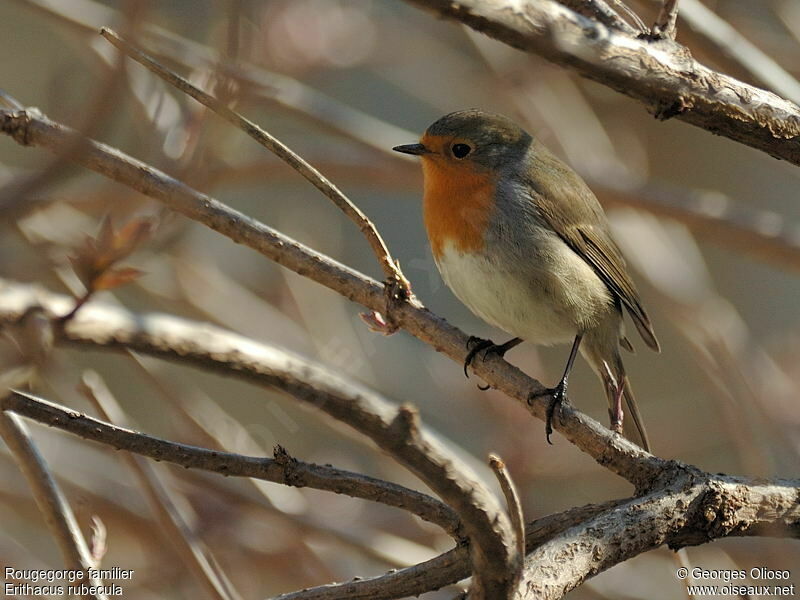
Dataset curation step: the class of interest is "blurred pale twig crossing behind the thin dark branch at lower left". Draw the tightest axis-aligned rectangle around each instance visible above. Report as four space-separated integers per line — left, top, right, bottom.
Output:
79 371 242 600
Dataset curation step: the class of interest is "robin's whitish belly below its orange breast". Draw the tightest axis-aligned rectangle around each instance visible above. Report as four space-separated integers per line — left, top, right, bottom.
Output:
436 240 613 345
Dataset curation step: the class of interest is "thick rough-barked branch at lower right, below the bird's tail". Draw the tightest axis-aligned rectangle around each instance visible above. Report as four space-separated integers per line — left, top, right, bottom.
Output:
518 476 800 599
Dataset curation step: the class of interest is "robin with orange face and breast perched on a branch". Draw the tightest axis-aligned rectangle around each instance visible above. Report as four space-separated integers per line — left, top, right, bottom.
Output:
393 109 660 451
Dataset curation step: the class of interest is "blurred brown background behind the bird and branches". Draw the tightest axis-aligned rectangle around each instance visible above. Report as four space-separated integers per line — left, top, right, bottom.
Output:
0 0 800 600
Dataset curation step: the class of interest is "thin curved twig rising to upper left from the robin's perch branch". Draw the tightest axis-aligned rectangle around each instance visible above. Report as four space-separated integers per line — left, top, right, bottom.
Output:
100 27 410 298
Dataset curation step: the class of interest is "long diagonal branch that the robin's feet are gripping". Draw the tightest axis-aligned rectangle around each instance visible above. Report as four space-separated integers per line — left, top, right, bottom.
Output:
0 109 663 487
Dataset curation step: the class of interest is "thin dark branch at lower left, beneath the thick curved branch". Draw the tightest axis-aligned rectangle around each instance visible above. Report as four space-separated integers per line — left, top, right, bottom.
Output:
3 392 459 535
